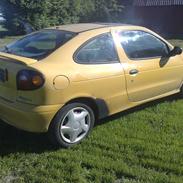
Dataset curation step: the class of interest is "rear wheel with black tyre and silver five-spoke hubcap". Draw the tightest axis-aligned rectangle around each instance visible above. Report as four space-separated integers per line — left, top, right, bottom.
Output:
48 103 95 148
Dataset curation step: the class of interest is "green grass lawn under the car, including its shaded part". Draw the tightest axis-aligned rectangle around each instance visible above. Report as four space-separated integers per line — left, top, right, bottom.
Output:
0 38 183 183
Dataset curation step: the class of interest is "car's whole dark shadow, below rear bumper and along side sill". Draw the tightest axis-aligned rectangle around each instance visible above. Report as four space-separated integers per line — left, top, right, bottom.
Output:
0 95 180 156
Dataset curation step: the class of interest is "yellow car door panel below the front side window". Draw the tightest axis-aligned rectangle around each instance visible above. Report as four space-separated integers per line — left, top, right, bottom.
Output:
126 56 183 102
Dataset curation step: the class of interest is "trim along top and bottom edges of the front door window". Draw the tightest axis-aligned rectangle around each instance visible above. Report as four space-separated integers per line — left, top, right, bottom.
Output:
120 29 171 61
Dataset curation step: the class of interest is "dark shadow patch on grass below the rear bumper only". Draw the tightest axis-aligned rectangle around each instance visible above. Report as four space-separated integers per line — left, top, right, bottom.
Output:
0 121 54 156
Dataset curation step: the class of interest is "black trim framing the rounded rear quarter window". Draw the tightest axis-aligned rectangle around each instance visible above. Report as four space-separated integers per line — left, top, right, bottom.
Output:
73 32 121 65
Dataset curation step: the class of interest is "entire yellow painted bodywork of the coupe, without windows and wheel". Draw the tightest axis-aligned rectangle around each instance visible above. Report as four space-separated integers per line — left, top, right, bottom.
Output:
0 25 183 132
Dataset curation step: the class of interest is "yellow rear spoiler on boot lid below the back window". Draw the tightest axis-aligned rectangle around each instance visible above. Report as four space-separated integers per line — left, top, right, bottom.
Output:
0 52 38 65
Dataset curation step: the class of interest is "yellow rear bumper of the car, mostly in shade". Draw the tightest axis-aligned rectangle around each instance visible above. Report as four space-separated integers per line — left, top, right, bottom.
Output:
0 98 63 132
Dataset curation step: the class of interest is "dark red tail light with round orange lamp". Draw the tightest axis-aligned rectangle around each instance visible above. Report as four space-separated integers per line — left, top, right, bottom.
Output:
17 70 45 90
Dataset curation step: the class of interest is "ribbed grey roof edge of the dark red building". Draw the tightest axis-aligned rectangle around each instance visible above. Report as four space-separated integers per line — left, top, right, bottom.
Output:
133 0 183 6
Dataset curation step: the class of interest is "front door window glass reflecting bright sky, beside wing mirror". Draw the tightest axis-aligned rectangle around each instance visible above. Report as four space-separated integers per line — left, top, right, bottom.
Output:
118 31 169 59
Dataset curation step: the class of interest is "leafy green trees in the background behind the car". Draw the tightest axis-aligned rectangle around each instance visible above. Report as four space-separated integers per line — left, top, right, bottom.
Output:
0 0 133 34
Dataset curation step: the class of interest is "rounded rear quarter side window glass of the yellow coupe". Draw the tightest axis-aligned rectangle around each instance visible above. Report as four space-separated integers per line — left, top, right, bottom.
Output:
75 33 119 64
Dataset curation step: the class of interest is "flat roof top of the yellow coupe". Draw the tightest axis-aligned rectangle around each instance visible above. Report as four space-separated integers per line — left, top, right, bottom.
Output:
49 23 129 33
